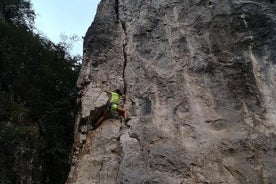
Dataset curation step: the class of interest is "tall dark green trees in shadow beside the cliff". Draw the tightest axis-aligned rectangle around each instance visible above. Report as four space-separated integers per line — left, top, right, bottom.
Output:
0 0 80 183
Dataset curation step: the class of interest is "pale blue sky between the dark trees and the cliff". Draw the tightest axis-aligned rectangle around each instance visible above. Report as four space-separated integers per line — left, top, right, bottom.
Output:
31 0 100 55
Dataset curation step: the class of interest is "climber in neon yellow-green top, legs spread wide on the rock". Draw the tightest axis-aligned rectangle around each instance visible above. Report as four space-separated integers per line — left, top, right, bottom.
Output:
93 89 130 128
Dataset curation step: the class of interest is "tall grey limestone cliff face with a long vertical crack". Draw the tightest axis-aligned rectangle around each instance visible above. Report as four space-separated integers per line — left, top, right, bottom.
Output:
67 0 276 184
